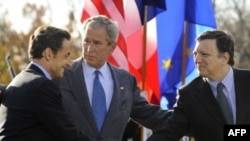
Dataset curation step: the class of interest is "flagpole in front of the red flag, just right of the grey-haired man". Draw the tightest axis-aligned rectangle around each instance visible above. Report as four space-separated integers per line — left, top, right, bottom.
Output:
140 5 148 141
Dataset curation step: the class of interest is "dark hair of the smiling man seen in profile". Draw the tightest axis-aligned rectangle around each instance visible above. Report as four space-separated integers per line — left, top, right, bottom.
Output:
28 26 71 59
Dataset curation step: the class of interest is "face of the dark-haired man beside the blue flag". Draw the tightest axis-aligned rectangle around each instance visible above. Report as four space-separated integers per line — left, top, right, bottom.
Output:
193 39 226 80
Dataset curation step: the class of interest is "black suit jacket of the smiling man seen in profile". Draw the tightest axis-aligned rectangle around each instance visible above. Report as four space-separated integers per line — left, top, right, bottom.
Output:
0 65 87 141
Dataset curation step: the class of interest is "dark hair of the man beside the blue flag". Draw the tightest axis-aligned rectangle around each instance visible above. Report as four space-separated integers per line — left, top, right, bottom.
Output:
196 30 234 66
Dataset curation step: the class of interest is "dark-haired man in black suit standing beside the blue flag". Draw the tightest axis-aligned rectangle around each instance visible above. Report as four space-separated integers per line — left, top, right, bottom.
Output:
148 30 250 141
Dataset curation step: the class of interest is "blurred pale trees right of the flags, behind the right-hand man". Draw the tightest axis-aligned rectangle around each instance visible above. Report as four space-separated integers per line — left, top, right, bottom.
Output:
215 0 250 69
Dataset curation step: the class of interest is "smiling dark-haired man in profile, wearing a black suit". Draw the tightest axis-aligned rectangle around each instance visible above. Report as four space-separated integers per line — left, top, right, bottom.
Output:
0 26 88 141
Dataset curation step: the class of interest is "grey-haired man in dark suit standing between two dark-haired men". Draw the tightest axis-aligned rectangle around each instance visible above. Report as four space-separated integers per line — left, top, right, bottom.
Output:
56 15 168 141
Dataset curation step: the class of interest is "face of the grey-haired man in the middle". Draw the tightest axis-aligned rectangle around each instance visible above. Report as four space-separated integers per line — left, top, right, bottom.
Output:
83 26 116 69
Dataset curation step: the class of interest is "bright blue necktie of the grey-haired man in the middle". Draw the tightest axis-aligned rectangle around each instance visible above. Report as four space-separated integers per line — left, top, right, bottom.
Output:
92 70 107 132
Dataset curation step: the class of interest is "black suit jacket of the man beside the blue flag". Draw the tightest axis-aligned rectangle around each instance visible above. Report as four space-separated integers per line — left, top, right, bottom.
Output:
148 69 250 141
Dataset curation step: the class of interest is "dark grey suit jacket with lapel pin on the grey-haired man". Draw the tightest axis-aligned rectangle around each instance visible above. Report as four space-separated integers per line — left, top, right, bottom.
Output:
57 58 167 141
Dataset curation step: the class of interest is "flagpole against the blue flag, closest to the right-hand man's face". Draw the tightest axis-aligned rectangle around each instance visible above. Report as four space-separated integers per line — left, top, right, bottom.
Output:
181 21 188 85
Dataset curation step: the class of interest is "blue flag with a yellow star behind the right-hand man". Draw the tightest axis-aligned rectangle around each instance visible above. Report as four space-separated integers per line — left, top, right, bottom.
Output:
156 0 216 109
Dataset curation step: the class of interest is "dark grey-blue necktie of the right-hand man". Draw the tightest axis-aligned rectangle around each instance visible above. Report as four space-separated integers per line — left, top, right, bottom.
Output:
217 83 234 124
